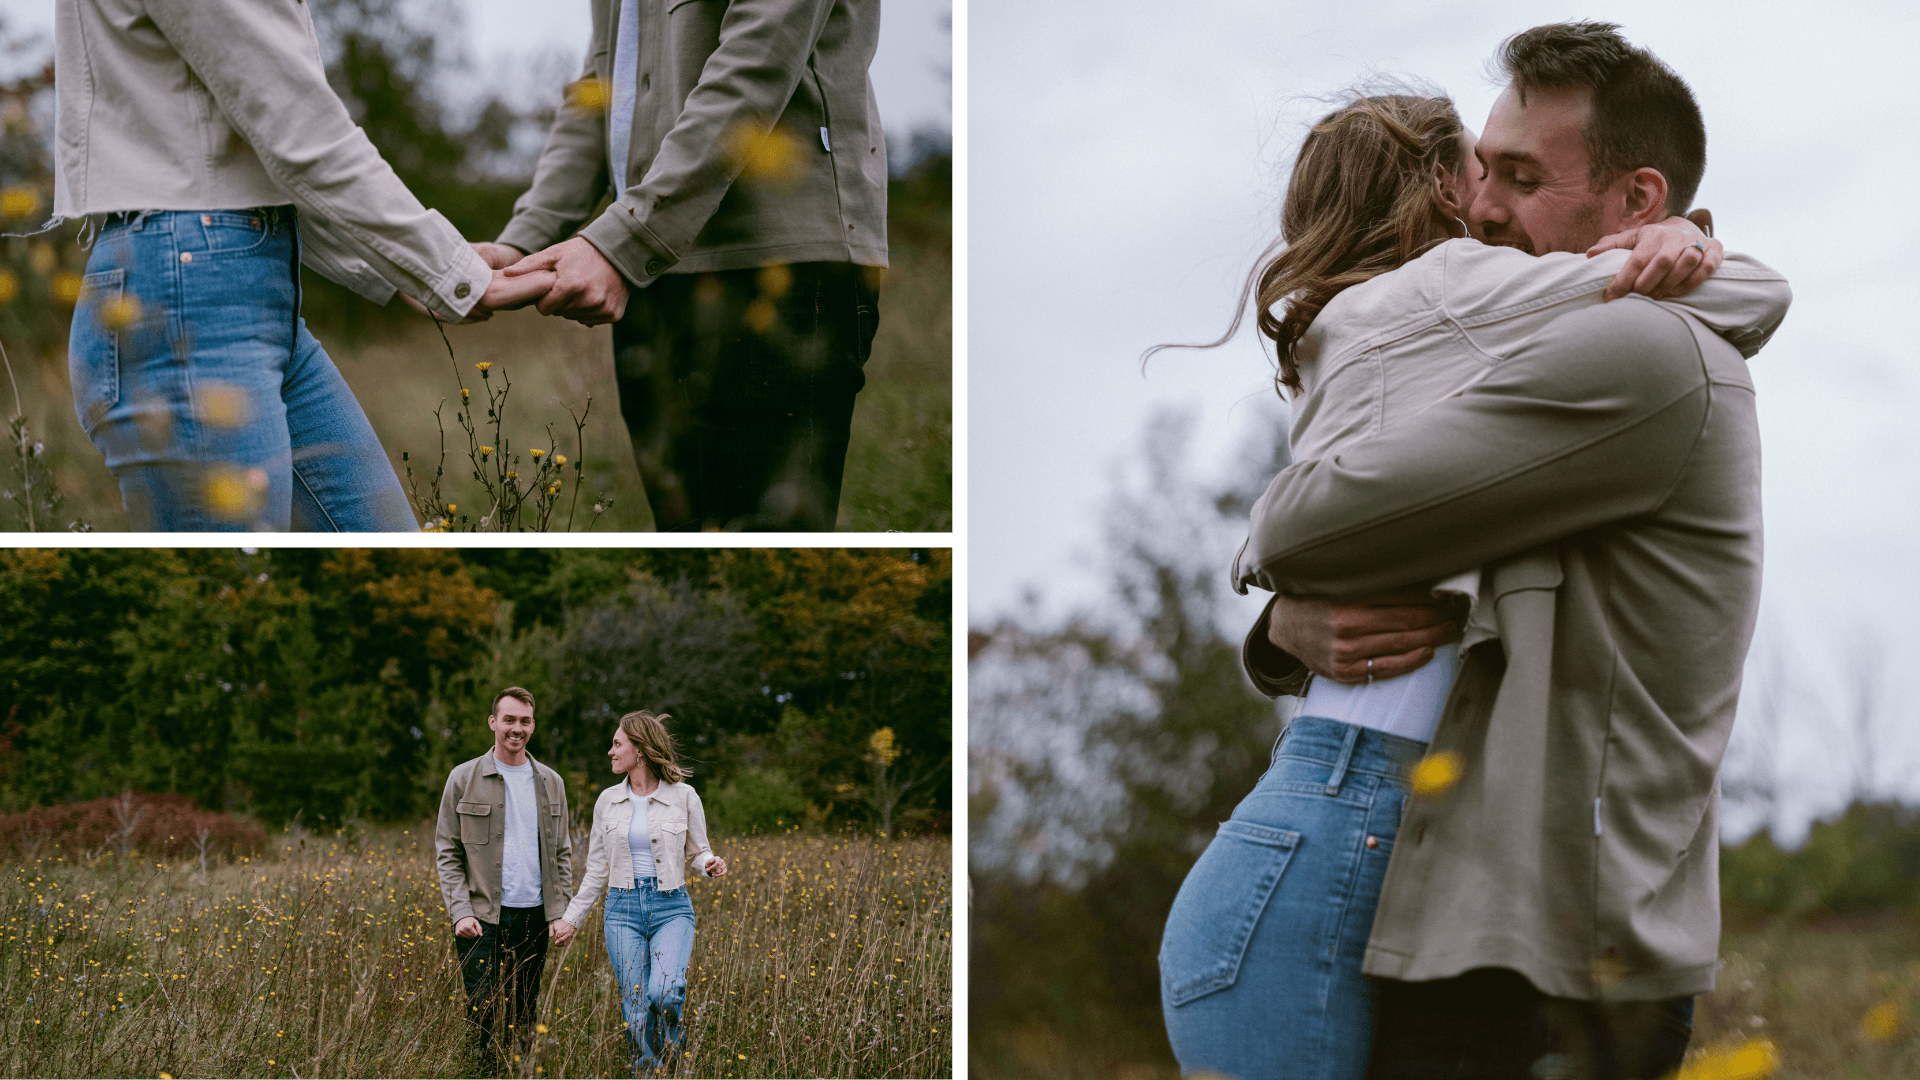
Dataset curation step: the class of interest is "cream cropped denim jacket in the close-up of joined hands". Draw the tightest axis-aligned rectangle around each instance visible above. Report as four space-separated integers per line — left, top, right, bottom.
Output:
54 0 493 321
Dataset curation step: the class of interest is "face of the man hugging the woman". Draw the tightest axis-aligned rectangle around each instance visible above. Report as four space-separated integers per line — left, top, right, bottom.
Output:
1467 86 1620 256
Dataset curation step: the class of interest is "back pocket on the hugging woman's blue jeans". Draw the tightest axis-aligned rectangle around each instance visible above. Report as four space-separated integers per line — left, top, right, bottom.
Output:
1160 821 1300 1005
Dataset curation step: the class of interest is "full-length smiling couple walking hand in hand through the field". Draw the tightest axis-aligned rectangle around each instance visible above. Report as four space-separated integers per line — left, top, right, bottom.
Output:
434 686 726 1076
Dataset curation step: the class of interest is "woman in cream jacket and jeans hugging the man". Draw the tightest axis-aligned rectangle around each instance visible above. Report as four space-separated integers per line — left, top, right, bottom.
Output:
1160 94 1789 1080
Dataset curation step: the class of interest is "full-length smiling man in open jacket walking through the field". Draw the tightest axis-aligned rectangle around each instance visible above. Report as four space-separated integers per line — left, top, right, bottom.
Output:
434 686 574 1065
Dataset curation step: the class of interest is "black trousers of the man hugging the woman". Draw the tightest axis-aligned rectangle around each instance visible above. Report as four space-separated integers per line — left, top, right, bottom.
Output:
1367 969 1693 1080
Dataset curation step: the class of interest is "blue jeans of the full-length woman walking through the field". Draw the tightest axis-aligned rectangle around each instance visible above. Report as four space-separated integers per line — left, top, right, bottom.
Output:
605 878 693 1074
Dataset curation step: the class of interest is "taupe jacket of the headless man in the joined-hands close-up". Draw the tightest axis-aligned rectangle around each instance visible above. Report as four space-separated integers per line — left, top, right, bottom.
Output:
499 0 887 286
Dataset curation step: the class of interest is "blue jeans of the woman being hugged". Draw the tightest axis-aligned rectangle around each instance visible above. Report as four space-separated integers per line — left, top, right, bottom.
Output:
1160 717 1427 1080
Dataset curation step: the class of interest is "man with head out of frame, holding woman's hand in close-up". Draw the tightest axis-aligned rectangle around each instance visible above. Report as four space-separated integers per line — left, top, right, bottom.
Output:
476 0 887 530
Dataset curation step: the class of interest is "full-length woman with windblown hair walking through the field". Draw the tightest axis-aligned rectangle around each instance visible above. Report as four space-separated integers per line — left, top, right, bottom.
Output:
561 711 726 1074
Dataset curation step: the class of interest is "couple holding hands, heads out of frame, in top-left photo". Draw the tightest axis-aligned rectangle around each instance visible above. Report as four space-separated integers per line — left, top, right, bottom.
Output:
54 0 887 532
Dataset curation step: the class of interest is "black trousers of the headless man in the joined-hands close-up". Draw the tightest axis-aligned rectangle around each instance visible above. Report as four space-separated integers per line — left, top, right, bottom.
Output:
612 263 879 532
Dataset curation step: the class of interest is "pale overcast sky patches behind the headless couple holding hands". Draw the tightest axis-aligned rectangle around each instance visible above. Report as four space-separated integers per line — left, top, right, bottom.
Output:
0 0 952 140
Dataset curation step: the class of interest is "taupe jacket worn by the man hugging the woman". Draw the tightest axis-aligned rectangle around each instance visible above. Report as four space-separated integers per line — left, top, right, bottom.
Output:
1242 296 1761 999
